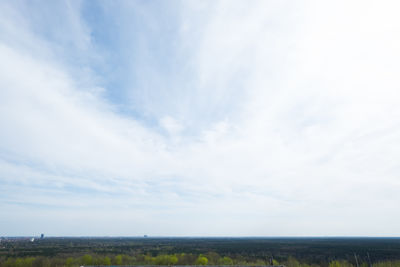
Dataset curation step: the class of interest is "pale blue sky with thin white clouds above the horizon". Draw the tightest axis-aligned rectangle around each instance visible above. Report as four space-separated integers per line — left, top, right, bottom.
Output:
0 0 400 236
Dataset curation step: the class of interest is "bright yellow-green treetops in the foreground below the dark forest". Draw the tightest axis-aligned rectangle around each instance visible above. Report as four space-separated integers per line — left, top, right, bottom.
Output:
0 252 400 267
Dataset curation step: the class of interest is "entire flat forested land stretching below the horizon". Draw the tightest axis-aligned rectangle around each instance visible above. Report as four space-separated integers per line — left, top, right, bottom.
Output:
0 237 400 267
